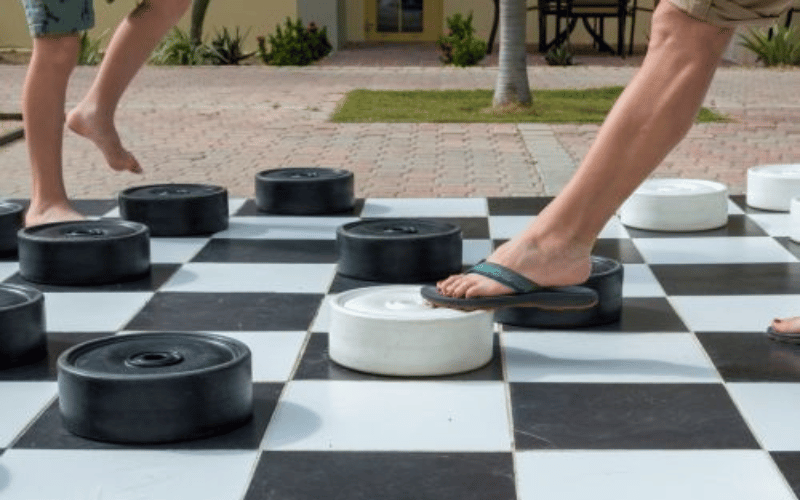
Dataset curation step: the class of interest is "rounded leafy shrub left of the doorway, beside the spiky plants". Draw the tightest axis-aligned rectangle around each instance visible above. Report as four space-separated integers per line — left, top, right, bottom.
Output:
258 17 333 66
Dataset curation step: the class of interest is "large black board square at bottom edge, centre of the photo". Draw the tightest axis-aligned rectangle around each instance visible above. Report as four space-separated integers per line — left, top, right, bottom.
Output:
245 452 516 500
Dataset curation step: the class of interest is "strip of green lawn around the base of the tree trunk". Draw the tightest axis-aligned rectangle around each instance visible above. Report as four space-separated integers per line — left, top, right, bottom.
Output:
332 87 727 123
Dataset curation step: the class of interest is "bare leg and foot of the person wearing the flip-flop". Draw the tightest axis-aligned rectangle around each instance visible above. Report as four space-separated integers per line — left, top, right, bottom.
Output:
438 1 732 297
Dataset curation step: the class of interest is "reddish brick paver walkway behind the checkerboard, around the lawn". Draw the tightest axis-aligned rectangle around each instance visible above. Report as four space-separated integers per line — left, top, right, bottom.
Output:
0 49 800 198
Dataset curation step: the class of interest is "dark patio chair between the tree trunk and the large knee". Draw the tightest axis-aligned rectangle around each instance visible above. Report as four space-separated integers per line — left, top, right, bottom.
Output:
532 0 640 57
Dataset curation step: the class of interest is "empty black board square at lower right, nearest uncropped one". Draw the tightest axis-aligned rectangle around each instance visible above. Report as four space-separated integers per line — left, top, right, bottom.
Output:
511 383 758 450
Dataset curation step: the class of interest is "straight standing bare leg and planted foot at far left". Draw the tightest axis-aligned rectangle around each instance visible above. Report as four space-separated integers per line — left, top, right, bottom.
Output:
22 35 83 225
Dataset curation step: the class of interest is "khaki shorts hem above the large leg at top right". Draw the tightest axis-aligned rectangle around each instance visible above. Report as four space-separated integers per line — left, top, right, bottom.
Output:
670 0 794 27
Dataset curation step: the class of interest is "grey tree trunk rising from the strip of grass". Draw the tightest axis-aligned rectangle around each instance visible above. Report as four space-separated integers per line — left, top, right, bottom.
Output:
493 0 531 107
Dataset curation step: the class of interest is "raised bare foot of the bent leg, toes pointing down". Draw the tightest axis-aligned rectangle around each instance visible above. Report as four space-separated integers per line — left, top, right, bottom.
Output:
67 105 142 174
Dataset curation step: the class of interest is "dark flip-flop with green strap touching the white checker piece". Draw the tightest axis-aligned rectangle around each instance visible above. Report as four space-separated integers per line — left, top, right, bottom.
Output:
421 262 599 311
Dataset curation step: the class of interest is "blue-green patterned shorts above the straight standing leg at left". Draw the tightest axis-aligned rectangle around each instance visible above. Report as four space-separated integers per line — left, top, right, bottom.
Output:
22 0 94 37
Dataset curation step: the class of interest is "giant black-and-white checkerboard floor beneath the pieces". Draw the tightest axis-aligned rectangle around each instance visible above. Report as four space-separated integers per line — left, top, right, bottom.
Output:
0 197 800 500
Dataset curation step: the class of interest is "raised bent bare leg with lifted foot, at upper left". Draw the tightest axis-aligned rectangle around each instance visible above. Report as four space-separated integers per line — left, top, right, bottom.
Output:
67 0 190 173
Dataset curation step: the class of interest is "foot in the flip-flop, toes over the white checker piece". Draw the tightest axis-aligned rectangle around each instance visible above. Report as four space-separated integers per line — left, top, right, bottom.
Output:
436 233 592 298
